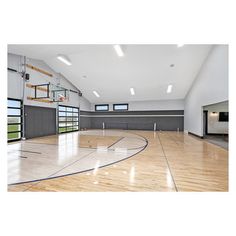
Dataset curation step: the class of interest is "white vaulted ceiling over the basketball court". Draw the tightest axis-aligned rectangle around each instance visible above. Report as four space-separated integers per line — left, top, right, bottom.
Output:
8 44 212 103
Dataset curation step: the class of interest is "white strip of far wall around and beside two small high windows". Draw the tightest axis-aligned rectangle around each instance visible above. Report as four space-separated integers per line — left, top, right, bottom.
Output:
91 100 184 111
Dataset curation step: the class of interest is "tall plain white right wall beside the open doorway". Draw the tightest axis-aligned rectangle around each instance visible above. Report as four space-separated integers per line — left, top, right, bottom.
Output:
184 45 228 136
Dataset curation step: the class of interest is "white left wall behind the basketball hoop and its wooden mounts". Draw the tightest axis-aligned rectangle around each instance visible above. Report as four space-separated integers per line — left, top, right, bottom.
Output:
8 54 91 110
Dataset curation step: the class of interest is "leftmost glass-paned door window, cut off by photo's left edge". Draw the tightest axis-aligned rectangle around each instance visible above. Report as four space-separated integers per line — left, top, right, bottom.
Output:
7 98 22 141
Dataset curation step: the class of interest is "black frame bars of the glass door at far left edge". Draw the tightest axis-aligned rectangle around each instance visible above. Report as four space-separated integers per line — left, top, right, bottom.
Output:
7 98 23 142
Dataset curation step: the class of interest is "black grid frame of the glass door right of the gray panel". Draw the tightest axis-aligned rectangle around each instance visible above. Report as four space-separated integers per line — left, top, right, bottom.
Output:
57 105 80 134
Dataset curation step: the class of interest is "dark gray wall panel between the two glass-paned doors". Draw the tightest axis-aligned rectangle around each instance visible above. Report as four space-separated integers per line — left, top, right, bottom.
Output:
24 106 56 138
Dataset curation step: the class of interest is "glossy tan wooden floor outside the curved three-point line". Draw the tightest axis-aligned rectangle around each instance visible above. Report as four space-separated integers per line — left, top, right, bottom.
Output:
8 131 228 192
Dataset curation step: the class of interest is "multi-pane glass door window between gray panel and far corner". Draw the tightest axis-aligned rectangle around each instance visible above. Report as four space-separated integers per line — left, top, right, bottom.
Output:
58 106 79 133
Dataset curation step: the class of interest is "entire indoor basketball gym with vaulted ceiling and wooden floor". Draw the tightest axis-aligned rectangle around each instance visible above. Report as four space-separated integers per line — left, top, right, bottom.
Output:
7 44 229 192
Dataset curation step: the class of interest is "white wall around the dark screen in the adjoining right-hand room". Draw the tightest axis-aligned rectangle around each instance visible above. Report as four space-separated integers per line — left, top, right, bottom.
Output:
204 102 229 134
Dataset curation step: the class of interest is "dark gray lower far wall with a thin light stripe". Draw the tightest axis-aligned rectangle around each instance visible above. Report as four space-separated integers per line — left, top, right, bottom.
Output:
80 110 184 131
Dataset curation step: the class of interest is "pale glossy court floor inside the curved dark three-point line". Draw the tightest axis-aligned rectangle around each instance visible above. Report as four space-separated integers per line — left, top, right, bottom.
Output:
8 130 147 184
